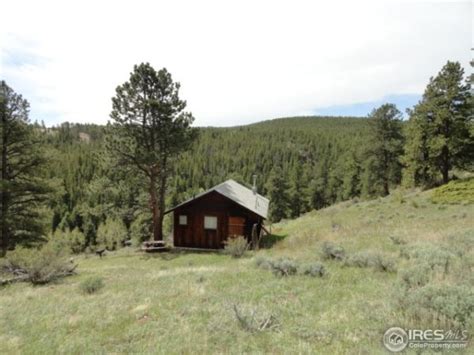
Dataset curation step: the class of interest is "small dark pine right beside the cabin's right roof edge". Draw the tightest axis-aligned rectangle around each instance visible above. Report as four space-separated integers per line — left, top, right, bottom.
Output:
267 166 290 222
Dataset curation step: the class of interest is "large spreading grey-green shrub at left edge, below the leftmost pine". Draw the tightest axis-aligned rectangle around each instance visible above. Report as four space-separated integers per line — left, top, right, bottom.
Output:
0 243 76 284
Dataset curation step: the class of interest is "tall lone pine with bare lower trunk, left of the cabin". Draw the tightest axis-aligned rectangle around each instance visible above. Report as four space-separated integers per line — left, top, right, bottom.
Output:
107 63 196 240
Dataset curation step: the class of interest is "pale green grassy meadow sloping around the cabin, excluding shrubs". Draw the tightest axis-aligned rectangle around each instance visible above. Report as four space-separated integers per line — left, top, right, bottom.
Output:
0 186 474 354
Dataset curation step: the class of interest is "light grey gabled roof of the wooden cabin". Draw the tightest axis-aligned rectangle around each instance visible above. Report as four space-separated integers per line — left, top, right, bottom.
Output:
165 179 269 218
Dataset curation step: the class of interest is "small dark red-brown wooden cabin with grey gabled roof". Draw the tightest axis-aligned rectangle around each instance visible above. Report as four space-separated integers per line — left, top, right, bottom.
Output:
165 180 269 249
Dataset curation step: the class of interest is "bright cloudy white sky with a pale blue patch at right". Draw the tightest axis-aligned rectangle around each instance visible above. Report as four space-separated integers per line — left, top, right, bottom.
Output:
0 0 474 126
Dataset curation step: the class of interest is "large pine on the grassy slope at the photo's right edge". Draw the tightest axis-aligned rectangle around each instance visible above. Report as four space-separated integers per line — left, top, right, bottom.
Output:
404 61 474 186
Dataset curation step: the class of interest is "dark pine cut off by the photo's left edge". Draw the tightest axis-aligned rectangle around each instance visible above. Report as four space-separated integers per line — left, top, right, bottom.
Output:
0 81 49 255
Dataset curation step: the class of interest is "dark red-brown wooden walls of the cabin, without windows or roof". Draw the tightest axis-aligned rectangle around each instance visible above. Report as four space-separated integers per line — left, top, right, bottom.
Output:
173 192 262 249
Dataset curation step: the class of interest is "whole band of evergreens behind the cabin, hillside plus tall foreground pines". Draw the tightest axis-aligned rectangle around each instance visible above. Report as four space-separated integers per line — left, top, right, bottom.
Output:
0 61 474 254
